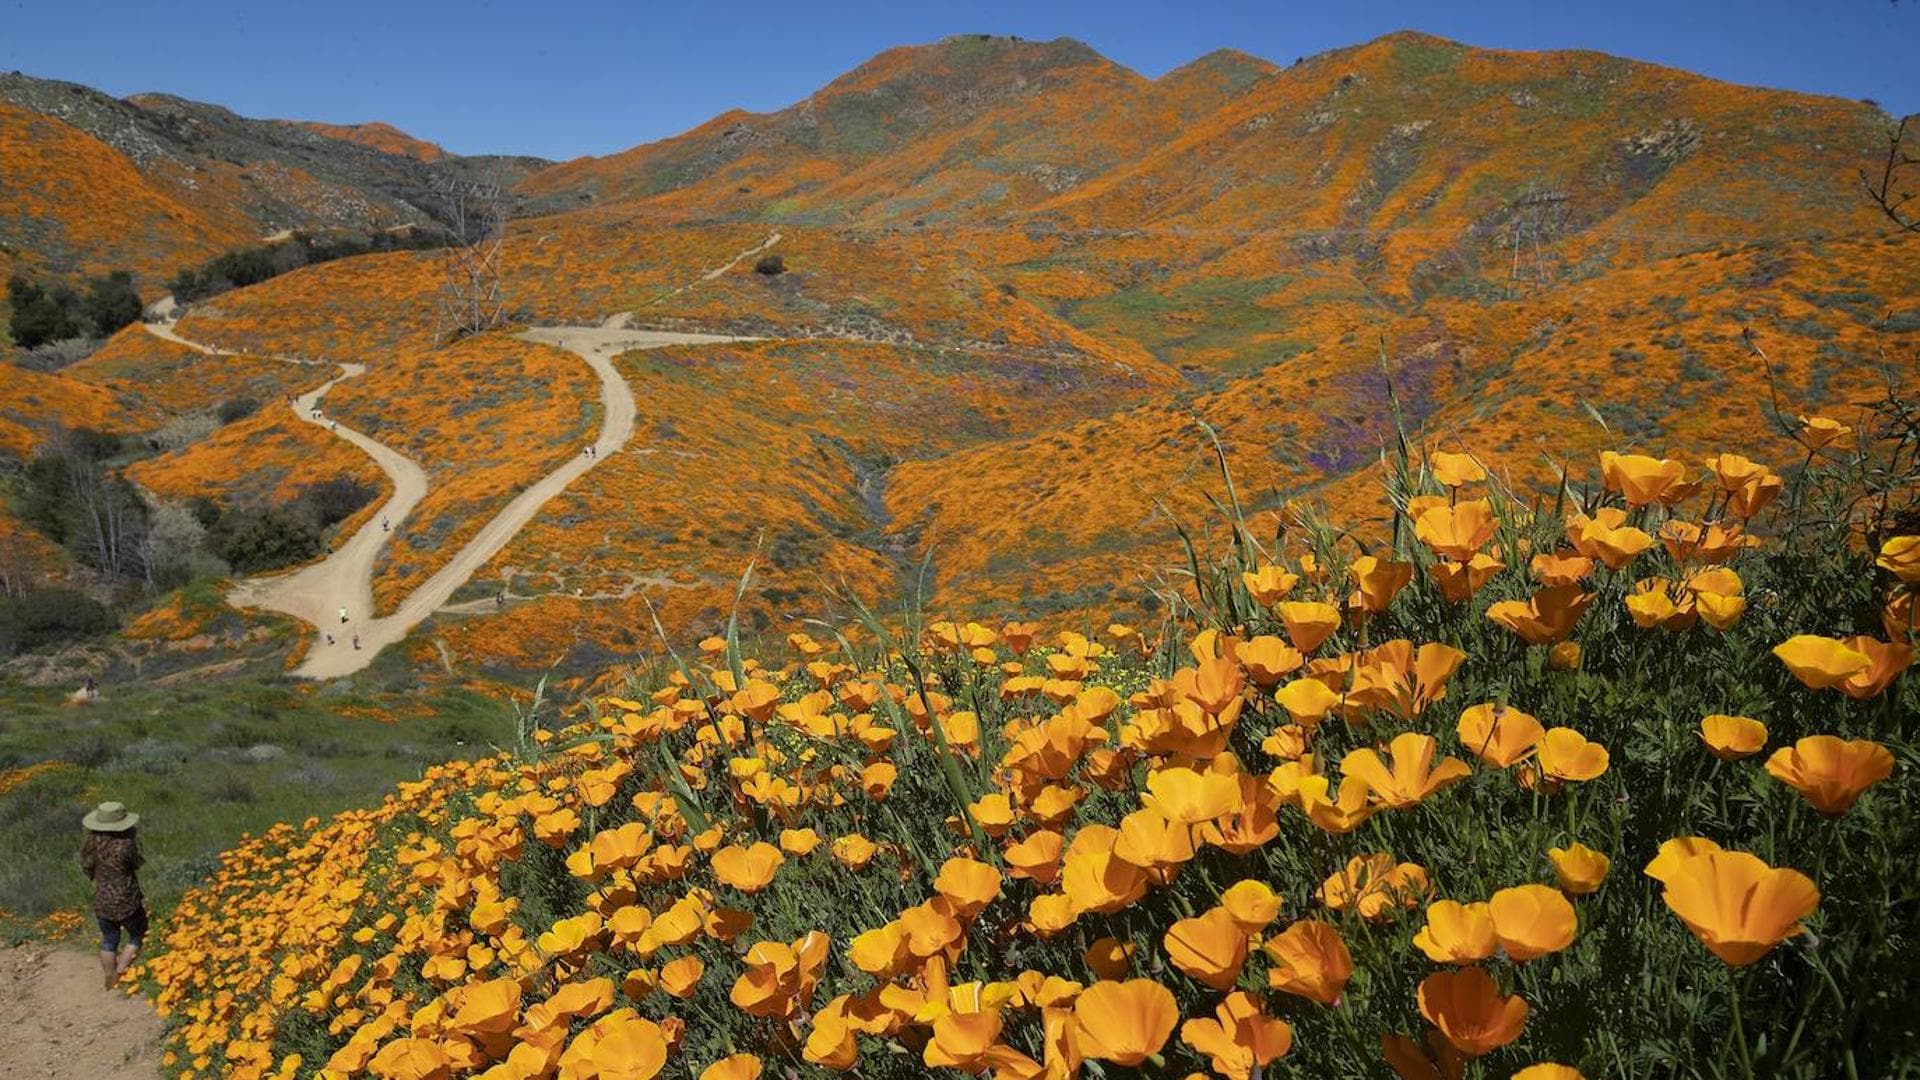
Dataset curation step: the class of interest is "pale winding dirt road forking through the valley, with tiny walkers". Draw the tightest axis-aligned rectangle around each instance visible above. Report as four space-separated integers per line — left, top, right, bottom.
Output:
146 315 755 678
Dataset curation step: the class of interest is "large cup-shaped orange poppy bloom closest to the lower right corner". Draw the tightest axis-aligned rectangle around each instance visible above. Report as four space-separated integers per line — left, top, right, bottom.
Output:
1661 851 1820 967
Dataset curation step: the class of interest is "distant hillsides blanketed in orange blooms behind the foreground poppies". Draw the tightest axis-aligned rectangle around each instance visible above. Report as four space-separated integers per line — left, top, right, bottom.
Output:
0 33 1920 671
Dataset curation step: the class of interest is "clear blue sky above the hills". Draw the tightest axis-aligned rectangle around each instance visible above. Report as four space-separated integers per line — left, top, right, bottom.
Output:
0 0 1920 158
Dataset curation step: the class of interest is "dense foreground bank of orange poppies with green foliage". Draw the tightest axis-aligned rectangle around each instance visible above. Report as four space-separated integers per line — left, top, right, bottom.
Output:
146 421 1920 1080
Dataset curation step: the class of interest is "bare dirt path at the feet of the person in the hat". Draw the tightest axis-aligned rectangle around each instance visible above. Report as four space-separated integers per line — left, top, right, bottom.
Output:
0 944 159 1080
